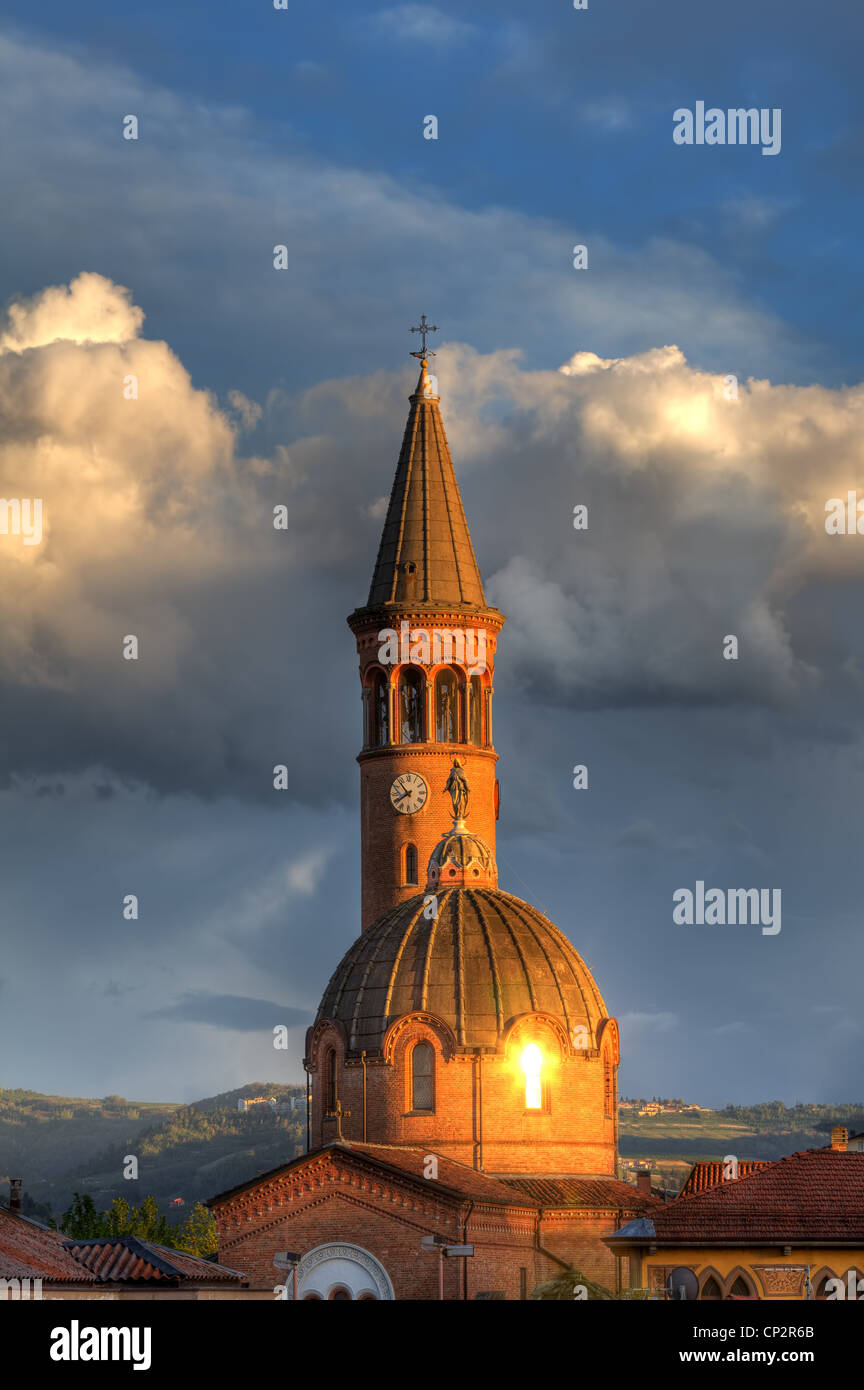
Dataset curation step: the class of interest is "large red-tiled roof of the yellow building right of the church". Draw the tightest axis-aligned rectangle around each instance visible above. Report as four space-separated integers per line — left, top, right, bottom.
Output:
651 1148 864 1247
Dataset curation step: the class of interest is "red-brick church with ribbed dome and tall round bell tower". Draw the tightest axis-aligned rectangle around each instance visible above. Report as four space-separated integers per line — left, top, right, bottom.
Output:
208 330 656 1301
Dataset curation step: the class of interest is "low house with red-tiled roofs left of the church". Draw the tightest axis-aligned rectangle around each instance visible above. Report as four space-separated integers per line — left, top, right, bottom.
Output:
0 1207 249 1302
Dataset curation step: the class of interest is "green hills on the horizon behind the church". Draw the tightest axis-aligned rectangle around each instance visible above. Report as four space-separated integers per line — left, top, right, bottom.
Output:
0 1081 864 1222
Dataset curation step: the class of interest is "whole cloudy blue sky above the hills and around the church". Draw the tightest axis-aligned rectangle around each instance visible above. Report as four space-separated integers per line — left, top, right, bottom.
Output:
0 0 864 1105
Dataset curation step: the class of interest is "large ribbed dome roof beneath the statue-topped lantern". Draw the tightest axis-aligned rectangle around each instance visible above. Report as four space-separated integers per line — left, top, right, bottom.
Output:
318 888 607 1052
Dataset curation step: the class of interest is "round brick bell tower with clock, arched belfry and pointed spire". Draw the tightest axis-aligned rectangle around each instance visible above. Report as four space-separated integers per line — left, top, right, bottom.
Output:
347 325 504 931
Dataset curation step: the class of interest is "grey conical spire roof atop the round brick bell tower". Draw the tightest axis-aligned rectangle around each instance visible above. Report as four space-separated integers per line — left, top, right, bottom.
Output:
368 357 486 607
